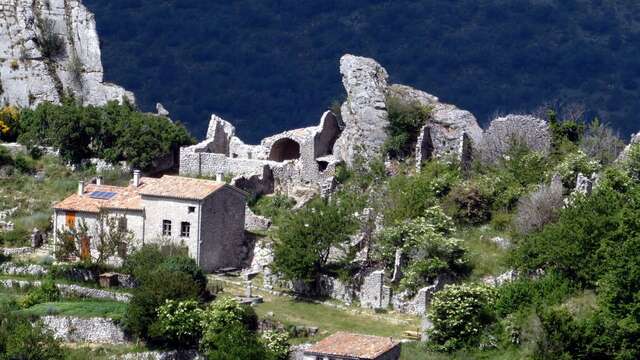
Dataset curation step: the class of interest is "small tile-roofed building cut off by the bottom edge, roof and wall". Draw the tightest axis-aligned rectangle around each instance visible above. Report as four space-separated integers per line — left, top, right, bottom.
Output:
302 332 400 360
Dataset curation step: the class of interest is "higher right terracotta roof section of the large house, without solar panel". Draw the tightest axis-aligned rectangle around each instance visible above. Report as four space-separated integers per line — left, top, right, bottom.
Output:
139 175 225 200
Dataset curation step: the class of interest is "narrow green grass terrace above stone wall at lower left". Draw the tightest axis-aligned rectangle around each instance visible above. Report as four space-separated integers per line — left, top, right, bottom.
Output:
18 300 127 320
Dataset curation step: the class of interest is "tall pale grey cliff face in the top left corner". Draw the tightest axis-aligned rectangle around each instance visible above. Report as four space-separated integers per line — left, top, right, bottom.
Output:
0 0 135 107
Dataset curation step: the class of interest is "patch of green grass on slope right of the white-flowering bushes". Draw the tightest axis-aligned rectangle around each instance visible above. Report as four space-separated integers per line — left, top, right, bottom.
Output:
454 226 509 280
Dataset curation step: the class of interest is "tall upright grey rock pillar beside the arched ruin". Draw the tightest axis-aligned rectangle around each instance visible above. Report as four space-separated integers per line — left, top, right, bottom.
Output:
334 55 389 165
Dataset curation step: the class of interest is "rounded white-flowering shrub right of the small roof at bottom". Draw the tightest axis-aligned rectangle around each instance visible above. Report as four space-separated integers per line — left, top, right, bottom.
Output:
429 284 495 351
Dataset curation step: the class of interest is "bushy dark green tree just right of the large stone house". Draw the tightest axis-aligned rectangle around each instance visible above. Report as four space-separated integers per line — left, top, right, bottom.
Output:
273 198 356 284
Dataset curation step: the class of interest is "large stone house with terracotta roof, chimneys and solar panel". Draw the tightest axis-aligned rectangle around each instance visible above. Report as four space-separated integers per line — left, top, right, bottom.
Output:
53 171 246 272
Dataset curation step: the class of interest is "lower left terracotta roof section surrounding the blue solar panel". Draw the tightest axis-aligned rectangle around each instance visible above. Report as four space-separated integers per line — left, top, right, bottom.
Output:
53 184 143 213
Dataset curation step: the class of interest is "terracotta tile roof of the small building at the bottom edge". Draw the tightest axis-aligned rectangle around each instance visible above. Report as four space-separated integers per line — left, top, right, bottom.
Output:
305 332 399 359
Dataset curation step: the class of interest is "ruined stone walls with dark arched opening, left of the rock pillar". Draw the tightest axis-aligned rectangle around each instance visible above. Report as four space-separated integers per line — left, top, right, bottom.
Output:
180 111 341 200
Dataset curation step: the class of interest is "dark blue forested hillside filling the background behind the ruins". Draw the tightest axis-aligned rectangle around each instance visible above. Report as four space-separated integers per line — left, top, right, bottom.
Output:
85 0 640 141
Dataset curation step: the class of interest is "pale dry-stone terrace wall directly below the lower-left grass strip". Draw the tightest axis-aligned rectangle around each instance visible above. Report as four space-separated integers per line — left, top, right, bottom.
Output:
41 316 127 345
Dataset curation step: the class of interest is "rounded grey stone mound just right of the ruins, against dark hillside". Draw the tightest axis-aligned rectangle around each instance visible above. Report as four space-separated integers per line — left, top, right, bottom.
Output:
479 115 551 162
